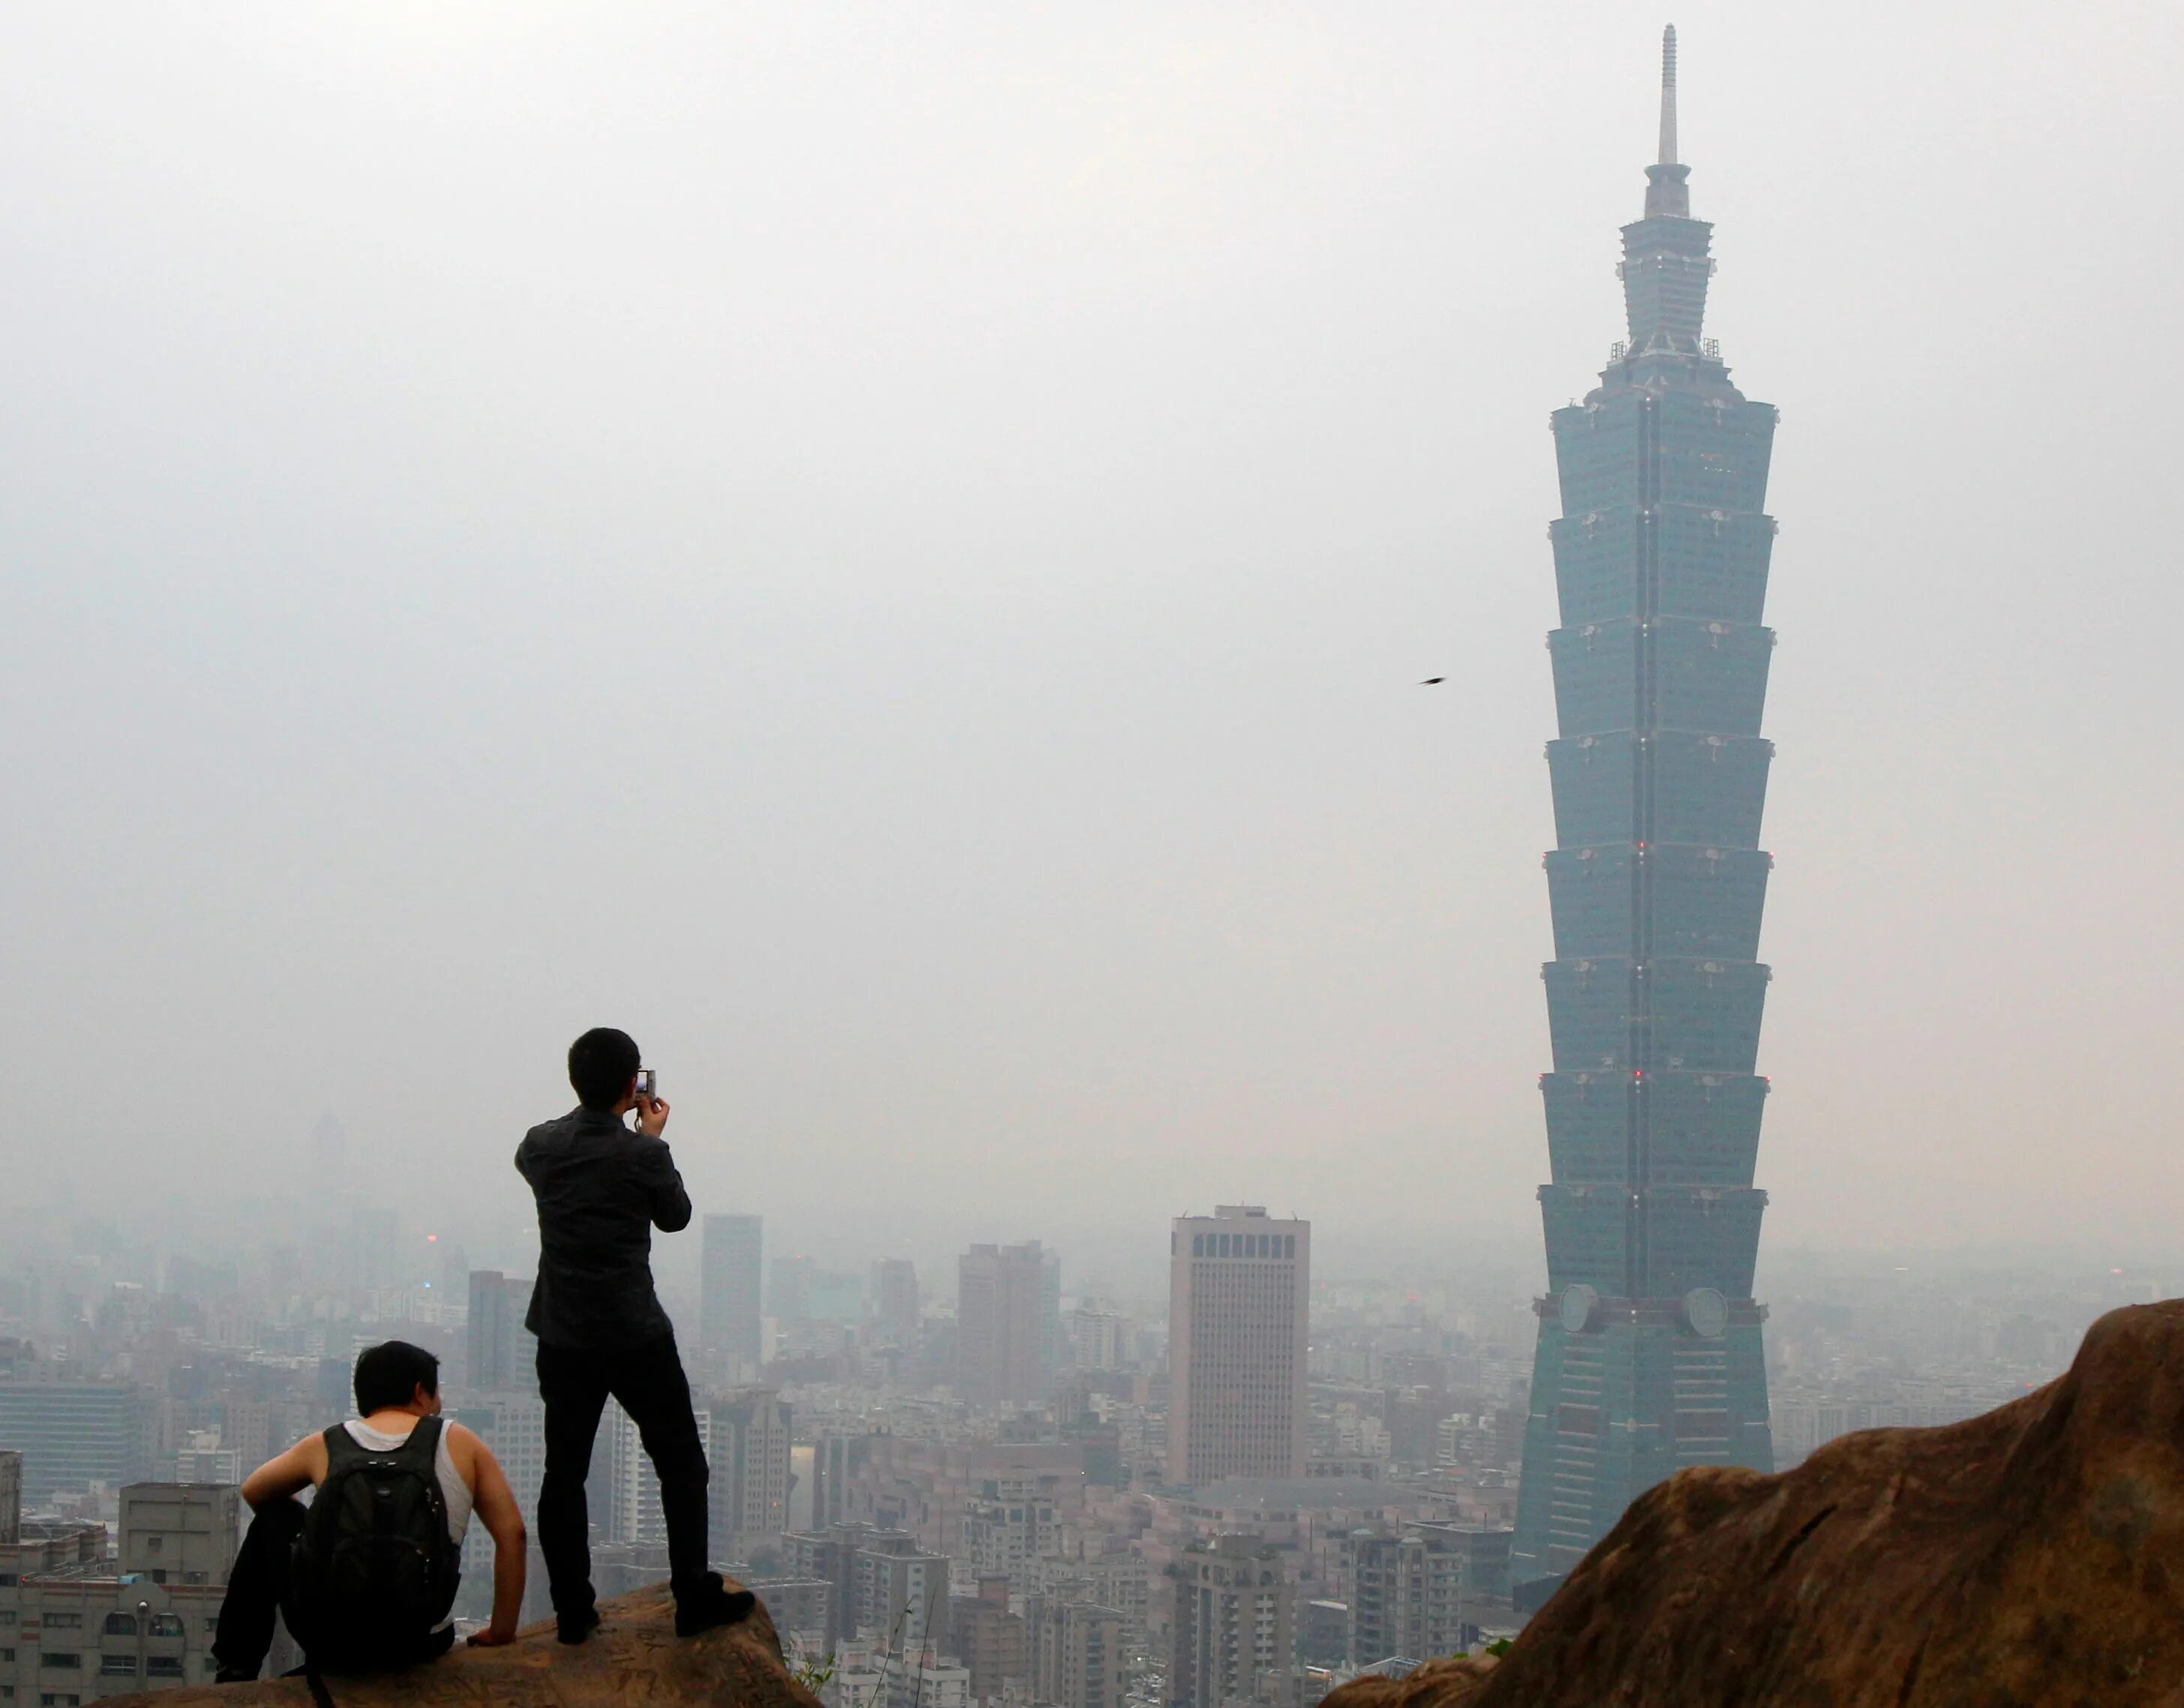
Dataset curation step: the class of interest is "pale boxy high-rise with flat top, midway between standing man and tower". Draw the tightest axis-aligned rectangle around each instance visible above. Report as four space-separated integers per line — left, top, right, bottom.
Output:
1168 1203 1313 1483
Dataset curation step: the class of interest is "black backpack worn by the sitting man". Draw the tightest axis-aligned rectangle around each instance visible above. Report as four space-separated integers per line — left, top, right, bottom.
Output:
288 1418 463 1673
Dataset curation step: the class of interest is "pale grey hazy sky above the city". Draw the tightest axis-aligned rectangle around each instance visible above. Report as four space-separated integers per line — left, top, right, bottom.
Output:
0 0 2184 1267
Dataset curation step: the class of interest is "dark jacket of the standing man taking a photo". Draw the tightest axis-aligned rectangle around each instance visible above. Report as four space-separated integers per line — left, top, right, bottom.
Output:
515 1107 690 1352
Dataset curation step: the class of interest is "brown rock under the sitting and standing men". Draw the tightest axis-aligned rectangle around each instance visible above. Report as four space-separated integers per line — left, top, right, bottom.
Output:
101 1586 819 1708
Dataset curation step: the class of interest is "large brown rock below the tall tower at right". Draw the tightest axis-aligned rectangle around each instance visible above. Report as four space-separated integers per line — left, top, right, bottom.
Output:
1328 1301 2184 1708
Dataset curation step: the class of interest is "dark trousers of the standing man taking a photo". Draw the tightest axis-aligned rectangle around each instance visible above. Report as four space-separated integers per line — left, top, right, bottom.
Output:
539 1332 710 1616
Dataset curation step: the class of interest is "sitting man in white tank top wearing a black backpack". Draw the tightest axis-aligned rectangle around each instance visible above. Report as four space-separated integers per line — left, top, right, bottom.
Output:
212 1341 524 1684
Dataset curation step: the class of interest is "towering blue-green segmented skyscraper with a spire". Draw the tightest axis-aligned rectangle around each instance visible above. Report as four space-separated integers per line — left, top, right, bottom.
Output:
1511 29 1776 1601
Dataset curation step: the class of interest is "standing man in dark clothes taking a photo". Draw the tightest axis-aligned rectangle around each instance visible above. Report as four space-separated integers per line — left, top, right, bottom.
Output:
515 1027 756 1643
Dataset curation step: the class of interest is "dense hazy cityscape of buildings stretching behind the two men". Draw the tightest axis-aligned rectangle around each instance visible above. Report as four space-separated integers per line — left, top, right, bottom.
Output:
0 1203 2173 1708
